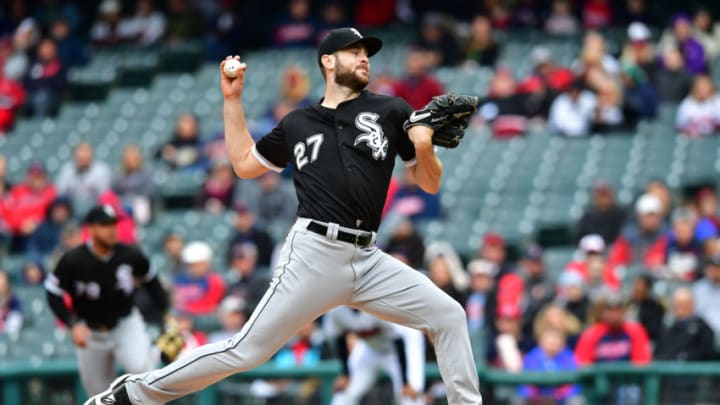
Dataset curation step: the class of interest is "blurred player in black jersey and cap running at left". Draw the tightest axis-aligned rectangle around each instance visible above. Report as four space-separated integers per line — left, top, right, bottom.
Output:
45 205 168 395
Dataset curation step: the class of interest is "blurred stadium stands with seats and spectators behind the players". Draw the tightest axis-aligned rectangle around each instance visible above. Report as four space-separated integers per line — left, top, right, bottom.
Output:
0 0 720 405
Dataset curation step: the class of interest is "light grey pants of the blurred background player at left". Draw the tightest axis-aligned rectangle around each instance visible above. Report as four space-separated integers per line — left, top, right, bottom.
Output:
76 309 153 396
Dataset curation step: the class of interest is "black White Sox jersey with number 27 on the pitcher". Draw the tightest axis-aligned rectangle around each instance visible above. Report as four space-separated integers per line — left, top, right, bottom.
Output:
253 91 415 231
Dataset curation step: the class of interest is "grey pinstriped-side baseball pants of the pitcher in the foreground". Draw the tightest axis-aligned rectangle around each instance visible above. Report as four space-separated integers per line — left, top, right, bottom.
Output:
126 218 482 405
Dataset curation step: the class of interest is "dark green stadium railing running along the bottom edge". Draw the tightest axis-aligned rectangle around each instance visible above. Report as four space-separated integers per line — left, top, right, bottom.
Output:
0 359 720 405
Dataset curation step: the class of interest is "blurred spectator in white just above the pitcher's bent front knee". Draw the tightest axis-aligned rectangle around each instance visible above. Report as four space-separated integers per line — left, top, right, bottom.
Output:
425 242 469 304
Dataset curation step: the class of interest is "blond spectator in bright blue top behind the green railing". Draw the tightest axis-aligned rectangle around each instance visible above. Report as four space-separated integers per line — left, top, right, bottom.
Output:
519 329 584 405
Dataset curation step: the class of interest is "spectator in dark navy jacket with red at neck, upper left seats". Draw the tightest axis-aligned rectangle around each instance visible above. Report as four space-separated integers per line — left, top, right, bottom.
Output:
25 38 67 117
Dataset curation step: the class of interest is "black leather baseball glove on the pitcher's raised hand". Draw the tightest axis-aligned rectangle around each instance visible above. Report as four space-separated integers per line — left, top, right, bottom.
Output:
403 93 480 148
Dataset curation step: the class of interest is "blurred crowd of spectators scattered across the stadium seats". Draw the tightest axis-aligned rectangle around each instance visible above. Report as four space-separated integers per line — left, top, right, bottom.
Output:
0 0 720 403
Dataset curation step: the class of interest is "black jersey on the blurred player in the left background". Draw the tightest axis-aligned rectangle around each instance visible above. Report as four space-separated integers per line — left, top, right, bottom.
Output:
45 244 155 325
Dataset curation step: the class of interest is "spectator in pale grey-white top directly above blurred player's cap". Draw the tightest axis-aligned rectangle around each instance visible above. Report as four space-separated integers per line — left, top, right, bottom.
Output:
55 143 112 208
